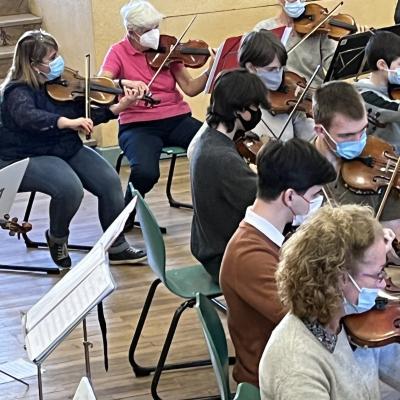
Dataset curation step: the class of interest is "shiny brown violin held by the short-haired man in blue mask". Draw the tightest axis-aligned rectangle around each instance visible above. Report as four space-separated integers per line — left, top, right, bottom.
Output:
340 135 400 194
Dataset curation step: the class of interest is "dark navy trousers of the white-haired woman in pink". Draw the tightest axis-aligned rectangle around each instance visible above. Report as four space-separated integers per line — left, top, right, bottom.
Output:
119 114 202 203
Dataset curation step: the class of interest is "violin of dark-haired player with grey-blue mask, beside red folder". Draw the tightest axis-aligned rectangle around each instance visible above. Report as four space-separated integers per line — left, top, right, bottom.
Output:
269 71 312 117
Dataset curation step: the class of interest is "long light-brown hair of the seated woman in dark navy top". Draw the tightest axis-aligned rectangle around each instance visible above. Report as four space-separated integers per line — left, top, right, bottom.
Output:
0 30 58 93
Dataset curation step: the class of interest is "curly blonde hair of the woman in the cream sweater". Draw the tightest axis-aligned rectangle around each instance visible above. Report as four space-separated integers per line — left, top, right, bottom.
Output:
275 204 383 324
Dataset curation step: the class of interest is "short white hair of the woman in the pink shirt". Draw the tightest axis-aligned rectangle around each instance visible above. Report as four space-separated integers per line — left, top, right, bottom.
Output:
121 0 164 30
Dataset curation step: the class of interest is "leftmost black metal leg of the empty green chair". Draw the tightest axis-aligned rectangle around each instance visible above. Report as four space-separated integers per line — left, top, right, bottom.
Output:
129 279 161 377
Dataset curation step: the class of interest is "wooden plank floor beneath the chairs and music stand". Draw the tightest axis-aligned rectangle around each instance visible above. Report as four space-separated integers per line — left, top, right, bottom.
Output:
0 159 234 400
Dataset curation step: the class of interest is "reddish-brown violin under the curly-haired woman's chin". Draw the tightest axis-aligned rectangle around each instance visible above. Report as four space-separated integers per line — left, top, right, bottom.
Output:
342 297 400 347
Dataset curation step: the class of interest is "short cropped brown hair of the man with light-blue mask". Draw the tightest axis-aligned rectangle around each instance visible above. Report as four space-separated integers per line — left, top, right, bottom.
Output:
313 81 365 130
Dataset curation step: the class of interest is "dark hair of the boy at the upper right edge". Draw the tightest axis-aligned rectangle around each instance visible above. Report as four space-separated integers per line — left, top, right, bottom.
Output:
365 31 400 71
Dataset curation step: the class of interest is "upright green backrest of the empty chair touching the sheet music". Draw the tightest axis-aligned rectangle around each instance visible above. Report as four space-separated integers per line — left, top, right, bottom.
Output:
129 183 165 284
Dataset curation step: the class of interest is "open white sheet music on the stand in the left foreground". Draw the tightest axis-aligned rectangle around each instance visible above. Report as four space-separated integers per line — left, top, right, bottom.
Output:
23 198 136 362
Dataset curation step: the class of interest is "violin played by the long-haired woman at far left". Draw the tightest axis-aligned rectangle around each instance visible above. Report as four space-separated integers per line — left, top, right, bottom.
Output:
46 68 160 107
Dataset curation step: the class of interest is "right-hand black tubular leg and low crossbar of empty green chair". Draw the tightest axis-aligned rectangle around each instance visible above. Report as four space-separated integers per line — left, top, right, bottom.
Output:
151 299 211 400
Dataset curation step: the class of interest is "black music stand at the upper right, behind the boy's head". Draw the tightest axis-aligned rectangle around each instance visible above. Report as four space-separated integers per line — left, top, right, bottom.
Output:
324 25 400 82
